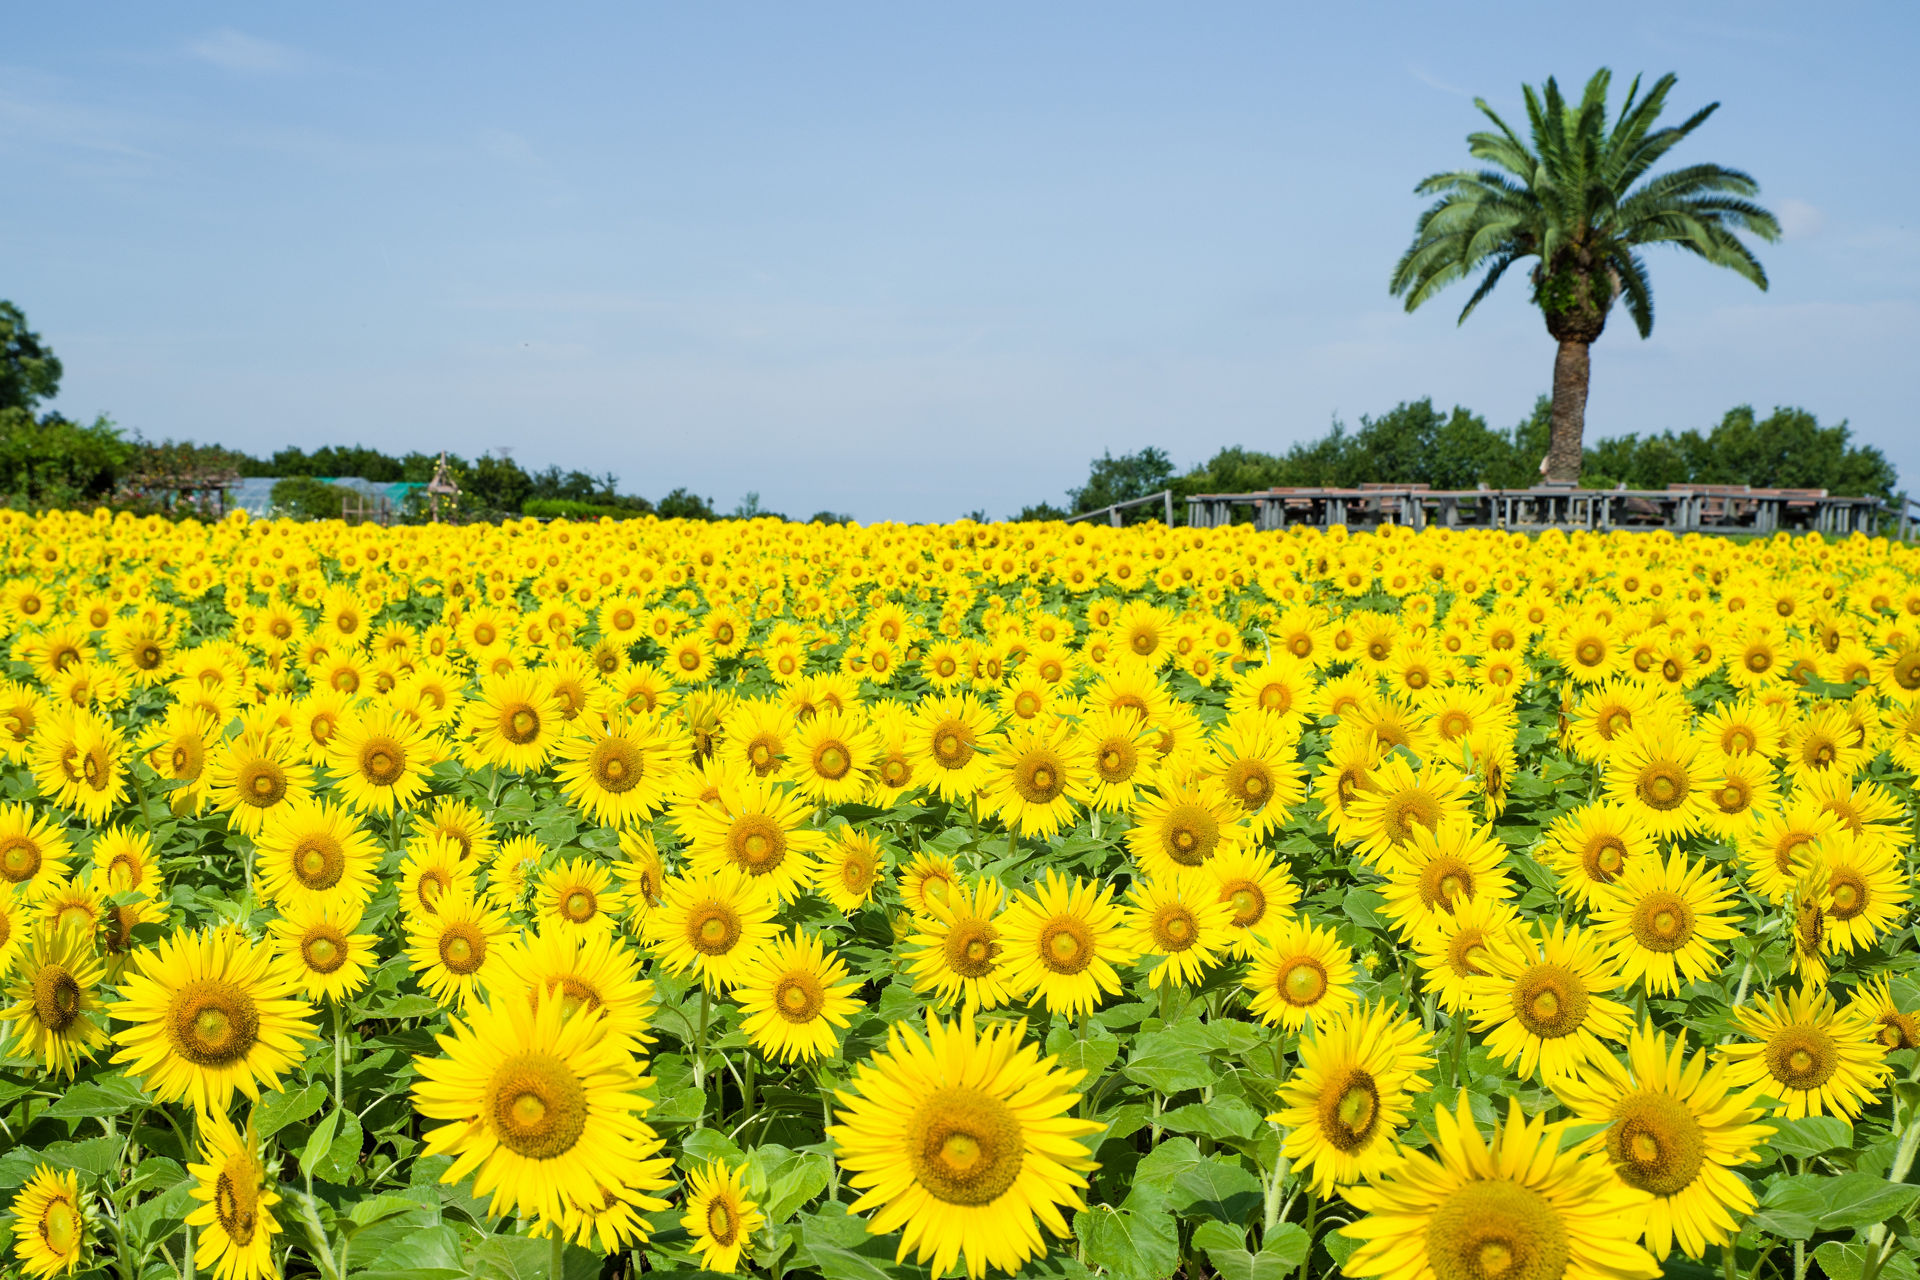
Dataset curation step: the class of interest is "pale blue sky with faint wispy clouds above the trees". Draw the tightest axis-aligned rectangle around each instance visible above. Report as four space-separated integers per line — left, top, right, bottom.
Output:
0 0 1920 520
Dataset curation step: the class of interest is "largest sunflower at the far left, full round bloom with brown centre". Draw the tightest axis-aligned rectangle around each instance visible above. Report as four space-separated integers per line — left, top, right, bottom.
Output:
108 929 313 1113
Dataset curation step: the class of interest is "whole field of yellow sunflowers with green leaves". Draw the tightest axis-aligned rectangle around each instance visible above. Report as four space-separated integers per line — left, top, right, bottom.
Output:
0 512 1920 1280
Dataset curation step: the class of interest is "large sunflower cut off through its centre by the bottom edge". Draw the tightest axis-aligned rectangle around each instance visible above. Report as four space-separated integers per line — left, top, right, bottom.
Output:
1340 1092 1661 1280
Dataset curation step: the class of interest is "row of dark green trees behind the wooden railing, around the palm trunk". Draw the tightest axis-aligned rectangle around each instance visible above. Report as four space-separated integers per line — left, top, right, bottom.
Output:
1018 395 1899 520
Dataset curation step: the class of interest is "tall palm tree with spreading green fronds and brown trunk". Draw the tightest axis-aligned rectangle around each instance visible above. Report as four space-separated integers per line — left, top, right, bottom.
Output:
1392 67 1780 482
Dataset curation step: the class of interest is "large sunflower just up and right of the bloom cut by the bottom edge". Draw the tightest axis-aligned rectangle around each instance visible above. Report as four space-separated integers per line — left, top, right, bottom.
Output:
1553 1023 1774 1261
